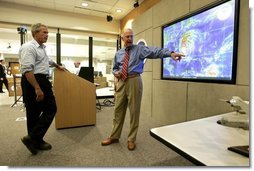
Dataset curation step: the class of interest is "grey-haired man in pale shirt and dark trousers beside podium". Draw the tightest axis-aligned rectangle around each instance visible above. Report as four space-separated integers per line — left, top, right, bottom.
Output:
19 23 64 155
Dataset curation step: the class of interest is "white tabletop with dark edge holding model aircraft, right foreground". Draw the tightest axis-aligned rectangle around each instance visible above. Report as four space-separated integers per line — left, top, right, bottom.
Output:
150 112 250 166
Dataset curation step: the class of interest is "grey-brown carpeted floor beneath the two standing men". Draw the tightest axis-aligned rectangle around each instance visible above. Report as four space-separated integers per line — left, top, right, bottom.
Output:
0 99 193 168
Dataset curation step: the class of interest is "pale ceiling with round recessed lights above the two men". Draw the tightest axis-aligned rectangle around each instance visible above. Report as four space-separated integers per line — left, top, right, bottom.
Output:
0 0 144 20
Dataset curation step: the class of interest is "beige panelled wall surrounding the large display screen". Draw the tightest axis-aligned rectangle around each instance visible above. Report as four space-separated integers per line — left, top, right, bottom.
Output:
133 0 250 124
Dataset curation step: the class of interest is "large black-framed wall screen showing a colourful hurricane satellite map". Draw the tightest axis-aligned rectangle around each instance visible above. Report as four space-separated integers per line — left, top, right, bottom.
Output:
161 0 239 84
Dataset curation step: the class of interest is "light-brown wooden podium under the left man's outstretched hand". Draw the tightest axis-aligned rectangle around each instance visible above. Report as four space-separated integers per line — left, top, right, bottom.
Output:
53 69 96 129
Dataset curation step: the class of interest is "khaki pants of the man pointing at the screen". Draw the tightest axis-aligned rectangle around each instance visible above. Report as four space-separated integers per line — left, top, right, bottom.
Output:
110 76 143 142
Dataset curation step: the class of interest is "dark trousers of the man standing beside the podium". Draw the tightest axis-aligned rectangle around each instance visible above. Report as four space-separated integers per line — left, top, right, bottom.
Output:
21 74 57 141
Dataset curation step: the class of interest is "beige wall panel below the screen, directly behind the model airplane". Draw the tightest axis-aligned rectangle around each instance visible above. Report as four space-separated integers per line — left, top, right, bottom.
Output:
187 83 249 120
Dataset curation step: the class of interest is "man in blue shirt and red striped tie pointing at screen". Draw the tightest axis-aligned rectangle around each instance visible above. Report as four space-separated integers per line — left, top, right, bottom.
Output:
101 29 184 150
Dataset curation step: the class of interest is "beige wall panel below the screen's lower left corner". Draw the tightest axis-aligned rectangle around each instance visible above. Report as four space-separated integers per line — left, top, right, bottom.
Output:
152 80 187 125
